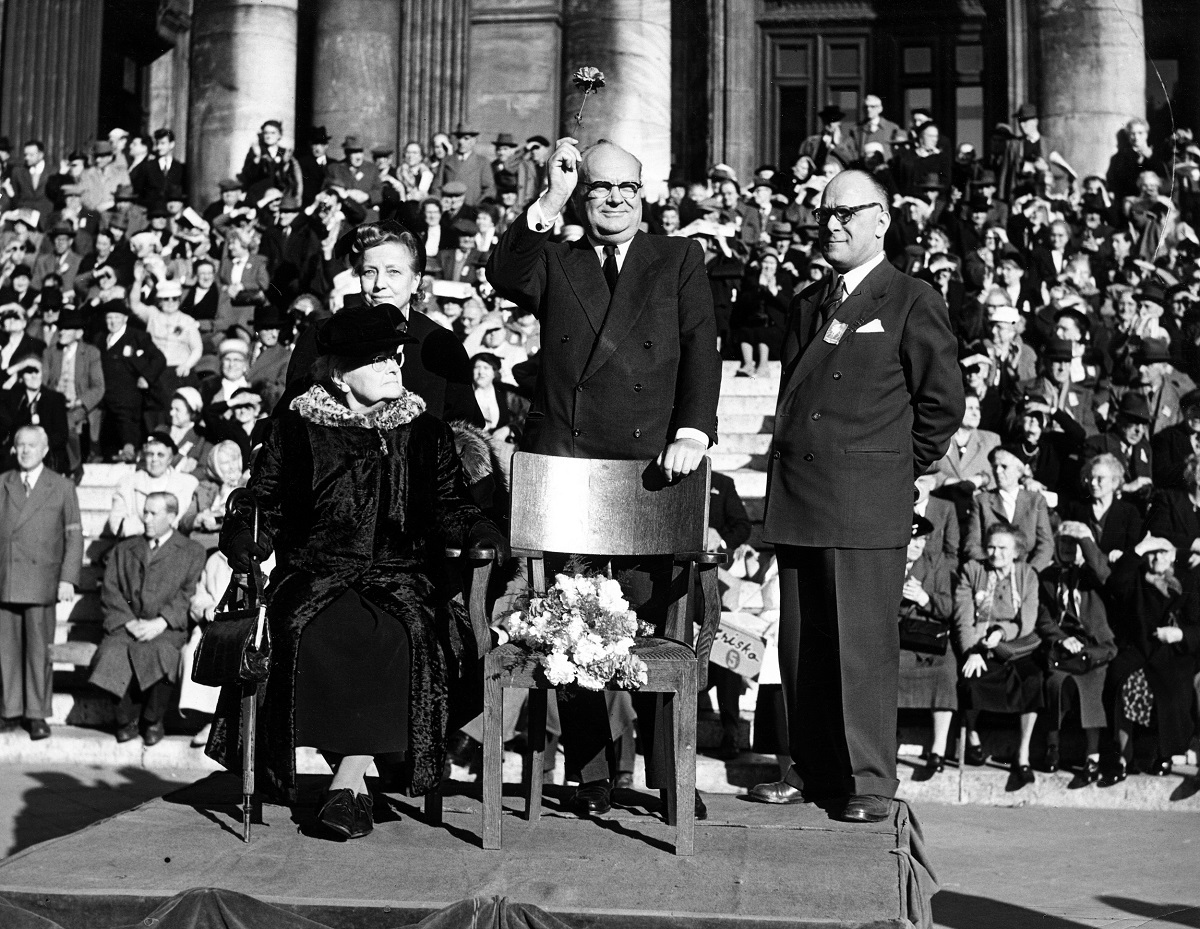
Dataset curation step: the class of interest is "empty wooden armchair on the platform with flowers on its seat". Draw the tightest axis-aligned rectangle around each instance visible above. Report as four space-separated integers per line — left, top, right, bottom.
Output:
484 452 725 855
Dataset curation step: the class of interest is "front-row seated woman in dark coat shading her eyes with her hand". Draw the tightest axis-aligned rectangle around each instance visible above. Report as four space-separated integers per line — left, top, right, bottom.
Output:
1037 521 1117 787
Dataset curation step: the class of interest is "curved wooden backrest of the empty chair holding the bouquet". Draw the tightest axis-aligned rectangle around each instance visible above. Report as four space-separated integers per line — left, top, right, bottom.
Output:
510 451 710 555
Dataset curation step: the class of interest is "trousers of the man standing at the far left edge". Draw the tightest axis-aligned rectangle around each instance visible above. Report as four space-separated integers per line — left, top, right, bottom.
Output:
0 604 55 719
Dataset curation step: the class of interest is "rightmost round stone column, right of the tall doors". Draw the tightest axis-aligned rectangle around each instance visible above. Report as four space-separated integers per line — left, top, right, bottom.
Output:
1031 0 1146 176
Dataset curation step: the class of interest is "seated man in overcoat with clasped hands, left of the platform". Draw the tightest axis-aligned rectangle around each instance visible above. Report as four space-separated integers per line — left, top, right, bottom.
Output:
91 492 204 745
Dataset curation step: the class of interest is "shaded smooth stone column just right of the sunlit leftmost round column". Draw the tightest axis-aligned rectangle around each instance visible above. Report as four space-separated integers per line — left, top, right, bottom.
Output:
312 0 402 152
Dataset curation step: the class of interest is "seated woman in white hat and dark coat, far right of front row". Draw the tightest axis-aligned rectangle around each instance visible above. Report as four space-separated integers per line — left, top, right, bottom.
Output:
1100 535 1200 787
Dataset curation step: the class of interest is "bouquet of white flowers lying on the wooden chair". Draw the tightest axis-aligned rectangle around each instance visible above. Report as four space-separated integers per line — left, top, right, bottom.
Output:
504 574 654 690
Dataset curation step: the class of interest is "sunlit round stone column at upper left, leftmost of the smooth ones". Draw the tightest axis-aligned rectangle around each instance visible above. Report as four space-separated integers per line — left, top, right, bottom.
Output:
187 0 296 206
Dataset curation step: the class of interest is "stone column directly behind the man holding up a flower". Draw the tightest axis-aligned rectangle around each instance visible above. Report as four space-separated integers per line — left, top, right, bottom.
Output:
562 0 671 200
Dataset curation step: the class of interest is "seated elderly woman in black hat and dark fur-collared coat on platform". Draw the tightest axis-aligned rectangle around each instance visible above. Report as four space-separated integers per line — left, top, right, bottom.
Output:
208 298 504 838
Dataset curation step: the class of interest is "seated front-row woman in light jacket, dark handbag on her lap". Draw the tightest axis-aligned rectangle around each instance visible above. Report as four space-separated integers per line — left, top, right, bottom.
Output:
954 523 1042 786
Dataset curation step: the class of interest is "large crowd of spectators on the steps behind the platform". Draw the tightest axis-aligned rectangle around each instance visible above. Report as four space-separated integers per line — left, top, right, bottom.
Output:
0 95 1200 784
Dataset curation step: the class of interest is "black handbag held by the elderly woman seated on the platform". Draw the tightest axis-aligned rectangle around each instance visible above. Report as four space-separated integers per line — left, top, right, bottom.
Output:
192 564 271 687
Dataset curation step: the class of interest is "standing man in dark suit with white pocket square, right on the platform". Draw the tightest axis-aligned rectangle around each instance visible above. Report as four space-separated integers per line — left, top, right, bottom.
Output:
751 170 964 822
